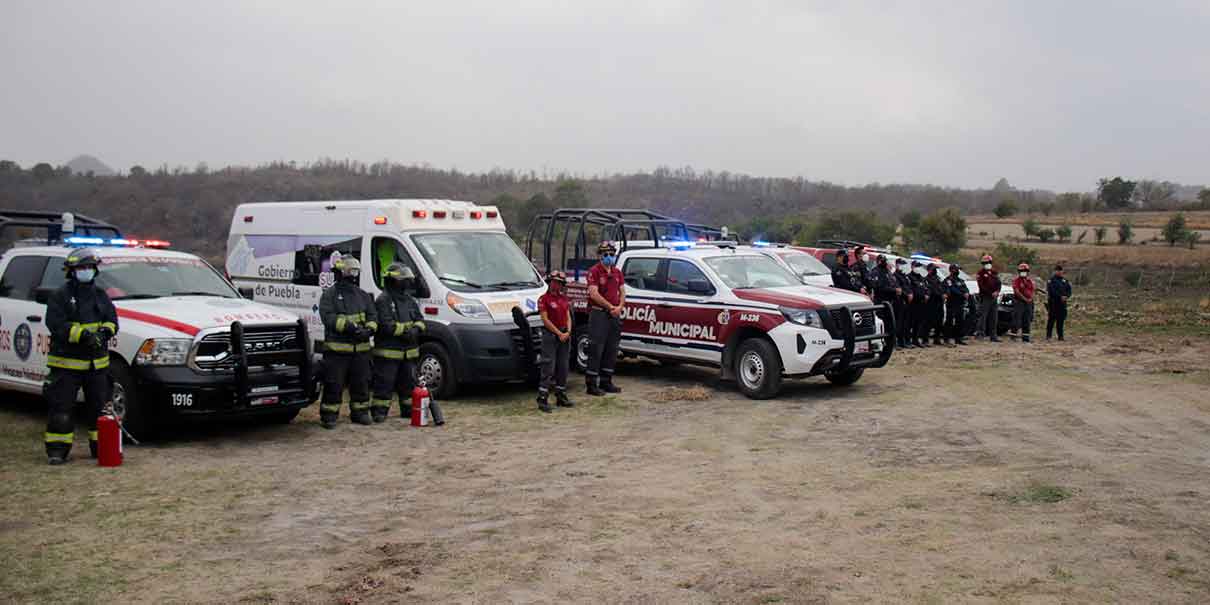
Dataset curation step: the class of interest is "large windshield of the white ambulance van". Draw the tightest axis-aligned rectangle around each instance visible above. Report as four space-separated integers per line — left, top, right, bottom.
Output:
411 231 542 292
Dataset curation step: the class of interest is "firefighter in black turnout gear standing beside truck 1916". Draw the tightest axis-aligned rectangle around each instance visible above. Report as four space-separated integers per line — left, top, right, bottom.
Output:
42 248 117 465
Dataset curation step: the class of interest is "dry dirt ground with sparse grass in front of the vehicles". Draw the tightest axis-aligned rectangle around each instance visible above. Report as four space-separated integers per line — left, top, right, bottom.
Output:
0 334 1210 604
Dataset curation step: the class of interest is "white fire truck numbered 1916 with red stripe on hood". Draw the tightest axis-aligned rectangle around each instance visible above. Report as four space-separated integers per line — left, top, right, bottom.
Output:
0 211 313 438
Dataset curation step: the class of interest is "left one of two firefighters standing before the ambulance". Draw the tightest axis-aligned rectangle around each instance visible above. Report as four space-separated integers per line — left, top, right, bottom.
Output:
319 257 378 428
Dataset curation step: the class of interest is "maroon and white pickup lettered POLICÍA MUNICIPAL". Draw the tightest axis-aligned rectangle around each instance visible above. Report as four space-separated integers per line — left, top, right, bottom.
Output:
567 241 894 399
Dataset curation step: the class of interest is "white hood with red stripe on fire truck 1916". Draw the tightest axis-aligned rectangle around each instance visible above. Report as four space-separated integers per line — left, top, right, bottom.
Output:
114 296 298 338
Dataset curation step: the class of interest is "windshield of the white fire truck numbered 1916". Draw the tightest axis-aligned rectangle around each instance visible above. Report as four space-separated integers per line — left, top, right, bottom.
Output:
97 257 240 300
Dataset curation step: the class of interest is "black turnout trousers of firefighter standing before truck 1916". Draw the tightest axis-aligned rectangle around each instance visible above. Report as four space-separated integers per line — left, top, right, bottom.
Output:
42 368 113 457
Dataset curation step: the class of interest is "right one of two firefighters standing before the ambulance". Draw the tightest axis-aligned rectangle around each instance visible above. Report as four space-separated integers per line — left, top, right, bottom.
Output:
370 263 425 422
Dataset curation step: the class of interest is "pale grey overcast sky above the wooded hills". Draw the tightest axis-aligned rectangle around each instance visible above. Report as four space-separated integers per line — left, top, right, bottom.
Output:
0 0 1210 190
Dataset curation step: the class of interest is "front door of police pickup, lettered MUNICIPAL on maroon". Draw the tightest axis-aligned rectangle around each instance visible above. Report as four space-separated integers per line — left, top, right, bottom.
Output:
650 259 730 363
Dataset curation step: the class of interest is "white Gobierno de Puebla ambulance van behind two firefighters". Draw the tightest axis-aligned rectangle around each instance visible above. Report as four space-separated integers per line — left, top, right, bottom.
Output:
226 200 546 397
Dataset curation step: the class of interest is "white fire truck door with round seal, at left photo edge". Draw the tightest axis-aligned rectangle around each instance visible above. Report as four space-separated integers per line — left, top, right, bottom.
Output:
0 255 50 392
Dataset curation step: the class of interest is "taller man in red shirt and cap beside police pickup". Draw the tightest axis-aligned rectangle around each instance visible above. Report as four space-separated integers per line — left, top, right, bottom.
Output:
584 241 626 397
